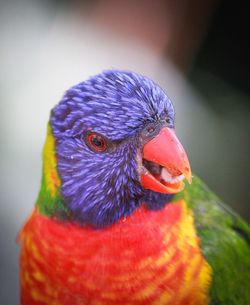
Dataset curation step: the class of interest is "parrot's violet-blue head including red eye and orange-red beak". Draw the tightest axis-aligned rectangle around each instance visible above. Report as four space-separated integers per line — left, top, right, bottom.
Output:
38 70 192 227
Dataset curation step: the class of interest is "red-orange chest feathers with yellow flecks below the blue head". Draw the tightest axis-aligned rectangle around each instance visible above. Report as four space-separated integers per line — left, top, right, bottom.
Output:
20 201 211 305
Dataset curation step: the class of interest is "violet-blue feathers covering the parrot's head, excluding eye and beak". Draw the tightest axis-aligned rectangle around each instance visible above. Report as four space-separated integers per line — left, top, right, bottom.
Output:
50 70 174 227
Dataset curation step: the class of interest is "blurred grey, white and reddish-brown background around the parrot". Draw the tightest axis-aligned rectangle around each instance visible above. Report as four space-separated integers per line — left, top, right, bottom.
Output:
0 0 250 305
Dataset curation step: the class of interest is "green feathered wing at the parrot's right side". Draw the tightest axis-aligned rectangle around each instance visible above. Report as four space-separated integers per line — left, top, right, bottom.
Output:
175 177 250 305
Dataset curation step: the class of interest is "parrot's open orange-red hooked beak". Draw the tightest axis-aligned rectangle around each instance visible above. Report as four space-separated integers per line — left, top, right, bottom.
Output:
141 127 192 194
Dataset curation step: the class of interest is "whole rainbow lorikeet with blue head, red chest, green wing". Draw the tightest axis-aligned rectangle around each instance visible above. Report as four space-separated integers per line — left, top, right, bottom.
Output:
19 70 250 305
